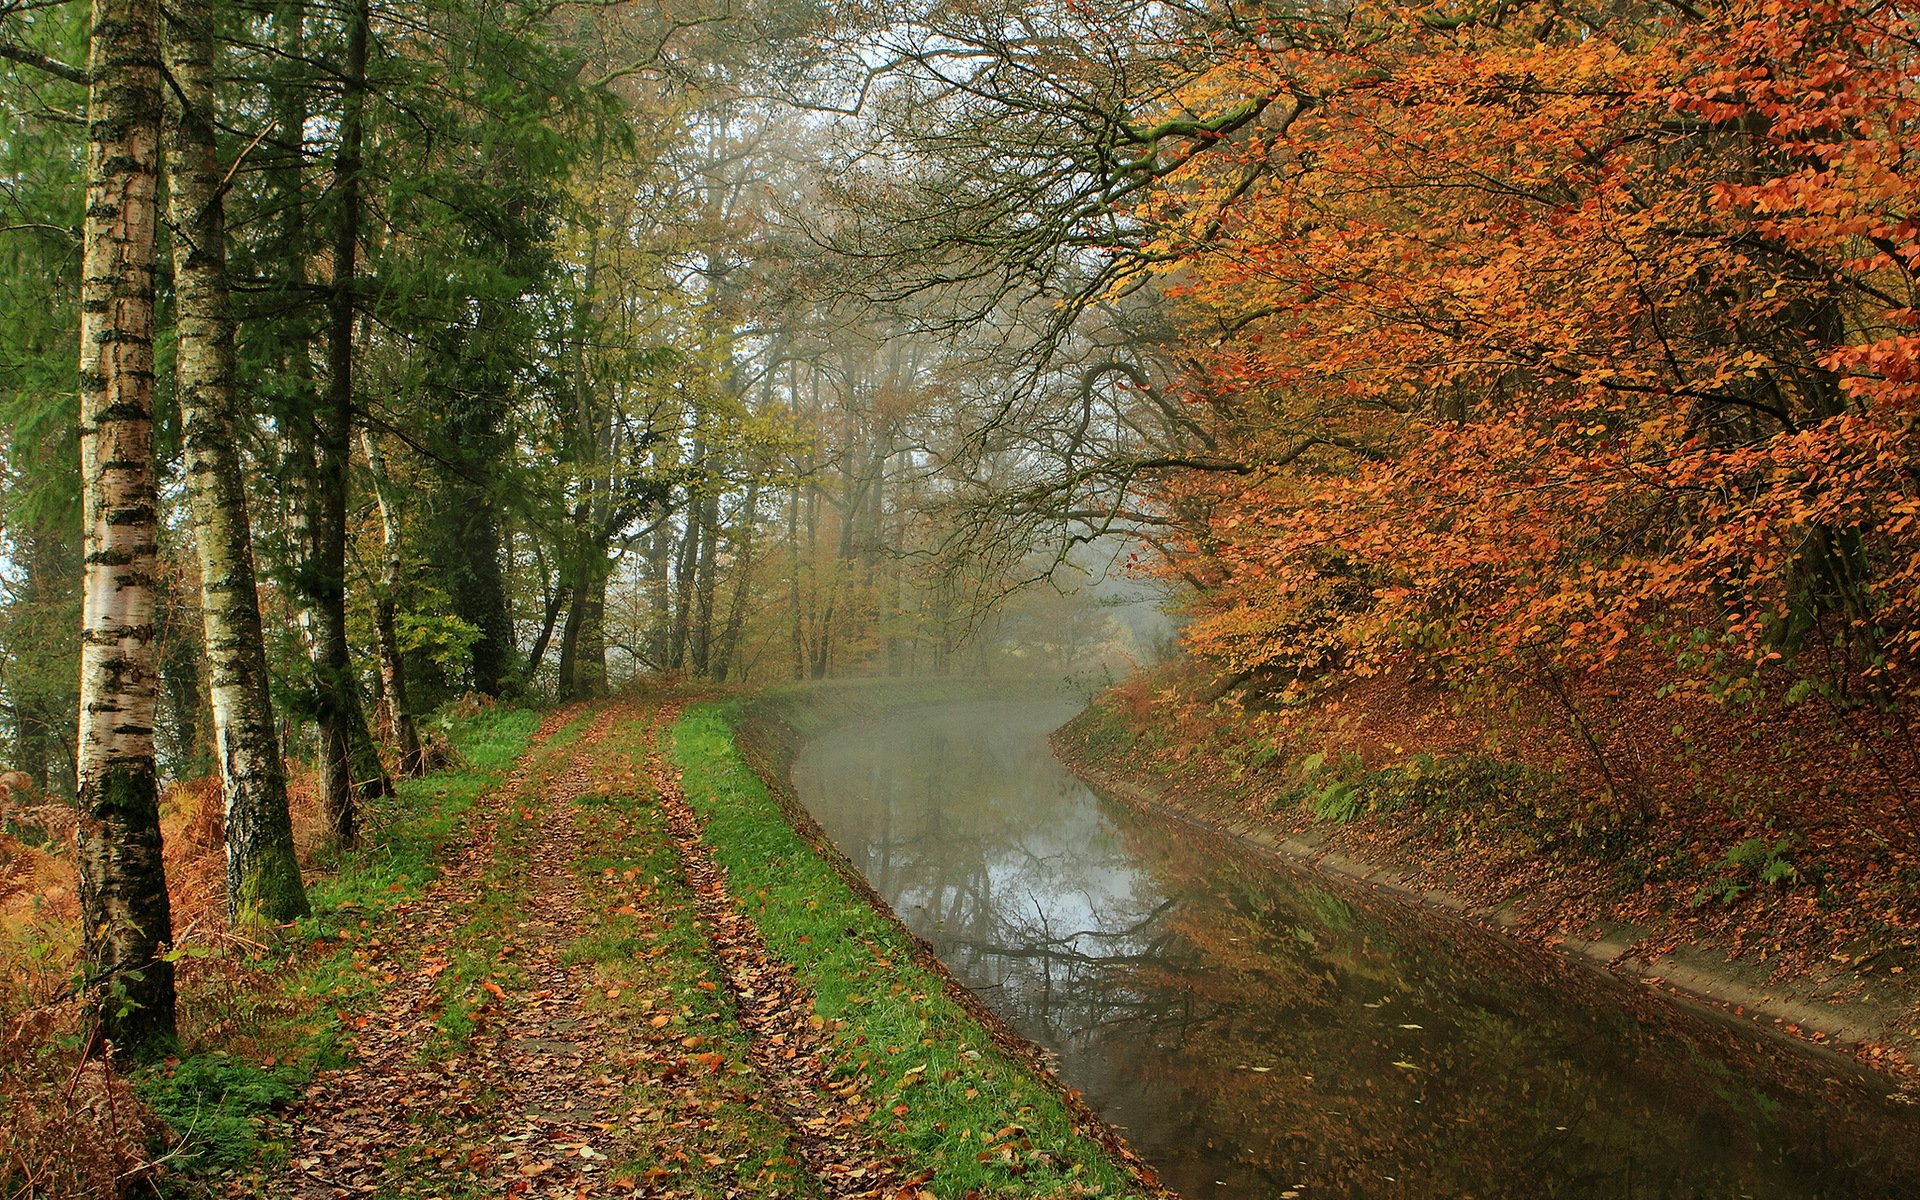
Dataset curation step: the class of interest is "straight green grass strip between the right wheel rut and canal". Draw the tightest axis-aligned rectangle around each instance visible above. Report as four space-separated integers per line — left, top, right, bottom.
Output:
668 705 1140 1198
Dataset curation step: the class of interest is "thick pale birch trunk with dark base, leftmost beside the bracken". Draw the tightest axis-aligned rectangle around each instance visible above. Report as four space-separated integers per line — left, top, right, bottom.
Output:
79 0 175 1054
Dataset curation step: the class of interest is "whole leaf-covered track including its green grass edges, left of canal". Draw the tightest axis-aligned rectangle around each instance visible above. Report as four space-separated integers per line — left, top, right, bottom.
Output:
154 701 1156 1200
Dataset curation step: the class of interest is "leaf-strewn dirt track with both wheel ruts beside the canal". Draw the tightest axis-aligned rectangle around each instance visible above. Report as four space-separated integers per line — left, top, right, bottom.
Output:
267 703 920 1200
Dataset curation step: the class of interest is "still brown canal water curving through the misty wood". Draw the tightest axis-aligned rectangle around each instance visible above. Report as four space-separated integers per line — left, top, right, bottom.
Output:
793 703 1920 1200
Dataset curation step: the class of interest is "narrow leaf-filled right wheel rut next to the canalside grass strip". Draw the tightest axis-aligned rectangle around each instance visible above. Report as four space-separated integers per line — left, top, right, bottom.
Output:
647 705 924 1200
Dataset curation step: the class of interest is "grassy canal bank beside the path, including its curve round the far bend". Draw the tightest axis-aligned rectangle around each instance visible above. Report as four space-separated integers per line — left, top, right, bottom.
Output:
670 680 1177 1200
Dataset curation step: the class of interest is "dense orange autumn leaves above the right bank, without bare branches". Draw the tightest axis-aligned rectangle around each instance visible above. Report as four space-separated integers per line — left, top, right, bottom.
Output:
1140 0 1920 708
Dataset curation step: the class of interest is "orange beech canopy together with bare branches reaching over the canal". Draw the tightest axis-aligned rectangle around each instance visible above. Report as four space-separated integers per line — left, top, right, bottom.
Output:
810 0 1920 806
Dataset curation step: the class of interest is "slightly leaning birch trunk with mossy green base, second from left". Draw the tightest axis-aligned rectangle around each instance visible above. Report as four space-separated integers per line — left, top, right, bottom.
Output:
167 0 309 922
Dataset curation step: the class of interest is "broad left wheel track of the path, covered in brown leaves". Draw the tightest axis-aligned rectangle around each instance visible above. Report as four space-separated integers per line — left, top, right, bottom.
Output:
286 705 632 1198
